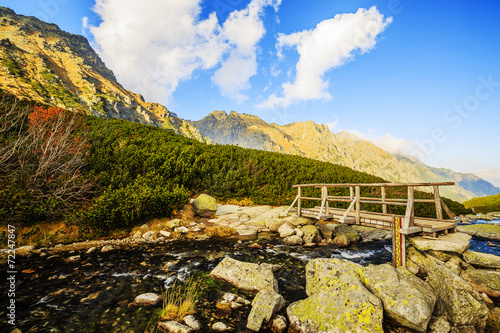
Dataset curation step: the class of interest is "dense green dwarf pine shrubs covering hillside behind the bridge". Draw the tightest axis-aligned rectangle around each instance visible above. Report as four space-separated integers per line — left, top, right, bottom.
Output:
0 89 469 232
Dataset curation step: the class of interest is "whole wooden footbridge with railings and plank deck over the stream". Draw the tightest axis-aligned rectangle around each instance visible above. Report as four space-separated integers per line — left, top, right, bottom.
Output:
288 182 458 237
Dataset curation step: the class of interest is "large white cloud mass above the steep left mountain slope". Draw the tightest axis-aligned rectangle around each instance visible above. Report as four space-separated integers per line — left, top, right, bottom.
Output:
91 0 281 102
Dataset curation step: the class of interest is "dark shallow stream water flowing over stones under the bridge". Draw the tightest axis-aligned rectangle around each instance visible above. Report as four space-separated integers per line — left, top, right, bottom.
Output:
0 220 500 333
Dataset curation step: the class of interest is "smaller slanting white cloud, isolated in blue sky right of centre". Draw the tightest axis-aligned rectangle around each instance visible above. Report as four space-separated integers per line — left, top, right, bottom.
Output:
258 7 392 108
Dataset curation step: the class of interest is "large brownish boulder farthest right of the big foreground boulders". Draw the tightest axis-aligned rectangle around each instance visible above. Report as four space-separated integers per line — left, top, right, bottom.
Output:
427 263 488 329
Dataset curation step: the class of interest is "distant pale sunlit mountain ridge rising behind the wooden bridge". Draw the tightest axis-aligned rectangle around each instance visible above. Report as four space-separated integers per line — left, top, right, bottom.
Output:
191 111 500 201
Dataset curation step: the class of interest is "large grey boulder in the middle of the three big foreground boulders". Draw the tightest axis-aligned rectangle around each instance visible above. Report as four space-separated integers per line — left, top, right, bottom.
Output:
359 264 436 332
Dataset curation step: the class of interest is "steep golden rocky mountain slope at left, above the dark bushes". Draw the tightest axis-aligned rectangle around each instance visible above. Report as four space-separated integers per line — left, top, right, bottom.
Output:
0 7 205 141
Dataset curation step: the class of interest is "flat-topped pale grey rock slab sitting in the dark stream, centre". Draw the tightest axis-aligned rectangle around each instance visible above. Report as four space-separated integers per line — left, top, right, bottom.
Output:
210 257 278 293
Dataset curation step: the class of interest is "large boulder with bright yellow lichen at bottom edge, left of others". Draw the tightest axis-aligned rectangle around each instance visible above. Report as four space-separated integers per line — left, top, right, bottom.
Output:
286 274 383 333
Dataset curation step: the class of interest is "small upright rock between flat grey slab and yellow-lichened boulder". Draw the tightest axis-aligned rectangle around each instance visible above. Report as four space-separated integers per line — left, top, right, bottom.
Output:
247 289 285 331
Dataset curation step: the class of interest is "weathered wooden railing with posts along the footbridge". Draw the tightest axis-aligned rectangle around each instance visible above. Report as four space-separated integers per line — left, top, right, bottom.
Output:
288 182 455 233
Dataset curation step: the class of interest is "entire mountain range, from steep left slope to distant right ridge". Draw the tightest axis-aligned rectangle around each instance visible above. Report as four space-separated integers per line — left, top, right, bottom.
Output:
0 7 500 201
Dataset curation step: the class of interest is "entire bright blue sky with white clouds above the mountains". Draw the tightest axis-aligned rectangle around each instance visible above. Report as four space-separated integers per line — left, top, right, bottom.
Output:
1 0 500 186
